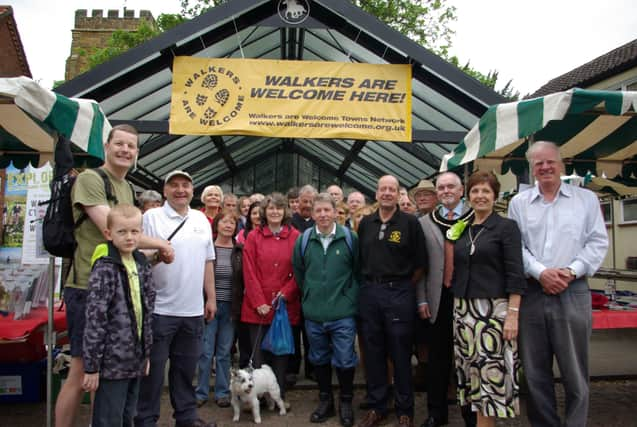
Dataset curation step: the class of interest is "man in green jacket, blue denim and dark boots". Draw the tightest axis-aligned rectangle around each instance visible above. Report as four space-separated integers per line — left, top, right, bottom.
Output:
293 193 359 427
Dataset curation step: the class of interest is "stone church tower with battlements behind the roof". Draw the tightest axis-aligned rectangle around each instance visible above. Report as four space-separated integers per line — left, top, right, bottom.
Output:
64 9 155 80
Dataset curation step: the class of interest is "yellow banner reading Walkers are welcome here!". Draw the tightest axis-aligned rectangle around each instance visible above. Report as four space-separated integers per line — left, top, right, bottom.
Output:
170 56 411 142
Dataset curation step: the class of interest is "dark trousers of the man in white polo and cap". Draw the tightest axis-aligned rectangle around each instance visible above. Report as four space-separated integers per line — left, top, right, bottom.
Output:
135 314 203 427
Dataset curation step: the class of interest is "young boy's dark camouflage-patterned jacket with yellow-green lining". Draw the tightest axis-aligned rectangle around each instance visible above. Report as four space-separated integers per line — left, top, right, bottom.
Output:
82 242 155 380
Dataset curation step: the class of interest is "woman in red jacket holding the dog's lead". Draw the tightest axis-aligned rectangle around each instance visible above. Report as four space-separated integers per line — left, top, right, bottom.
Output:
241 193 301 398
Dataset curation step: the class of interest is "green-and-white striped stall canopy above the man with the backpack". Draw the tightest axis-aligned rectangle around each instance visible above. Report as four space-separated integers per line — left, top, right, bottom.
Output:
0 77 111 167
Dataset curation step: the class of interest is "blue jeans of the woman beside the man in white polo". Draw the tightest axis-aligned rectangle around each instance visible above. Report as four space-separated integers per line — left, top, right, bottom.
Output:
195 301 234 400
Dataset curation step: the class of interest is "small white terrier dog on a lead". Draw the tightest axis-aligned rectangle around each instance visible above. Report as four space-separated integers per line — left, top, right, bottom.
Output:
230 365 285 424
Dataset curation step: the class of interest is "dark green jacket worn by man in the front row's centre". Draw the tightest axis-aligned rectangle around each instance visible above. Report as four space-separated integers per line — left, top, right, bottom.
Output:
292 224 360 322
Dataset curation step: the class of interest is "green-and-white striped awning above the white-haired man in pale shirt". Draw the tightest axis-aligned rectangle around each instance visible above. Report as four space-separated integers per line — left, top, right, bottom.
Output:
440 89 637 178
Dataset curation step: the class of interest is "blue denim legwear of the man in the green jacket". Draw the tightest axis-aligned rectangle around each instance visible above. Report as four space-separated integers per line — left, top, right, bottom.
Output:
305 317 358 369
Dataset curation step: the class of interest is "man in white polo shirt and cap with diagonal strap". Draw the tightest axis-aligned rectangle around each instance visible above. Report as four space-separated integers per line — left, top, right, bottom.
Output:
135 171 217 427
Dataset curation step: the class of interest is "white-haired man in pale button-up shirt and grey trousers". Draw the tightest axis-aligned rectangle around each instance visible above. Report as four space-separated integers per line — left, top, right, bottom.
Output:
509 141 608 426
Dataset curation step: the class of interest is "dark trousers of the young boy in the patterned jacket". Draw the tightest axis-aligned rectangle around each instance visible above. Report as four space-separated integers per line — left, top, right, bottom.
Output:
91 377 139 427
